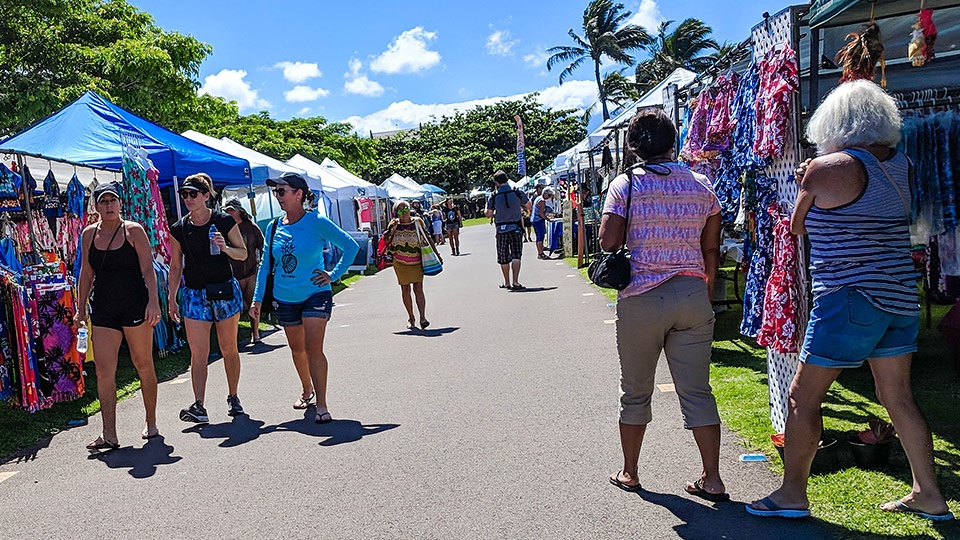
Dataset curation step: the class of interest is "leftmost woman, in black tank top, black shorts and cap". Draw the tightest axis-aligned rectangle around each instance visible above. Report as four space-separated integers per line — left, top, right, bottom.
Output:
74 183 160 452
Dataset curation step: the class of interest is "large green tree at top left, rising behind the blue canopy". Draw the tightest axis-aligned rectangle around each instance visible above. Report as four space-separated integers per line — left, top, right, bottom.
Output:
0 0 228 133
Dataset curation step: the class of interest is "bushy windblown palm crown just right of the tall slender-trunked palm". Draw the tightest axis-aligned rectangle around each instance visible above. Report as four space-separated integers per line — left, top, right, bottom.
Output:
636 19 720 94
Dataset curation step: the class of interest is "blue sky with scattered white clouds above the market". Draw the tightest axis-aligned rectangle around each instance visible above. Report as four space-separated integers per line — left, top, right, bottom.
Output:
129 0 788 135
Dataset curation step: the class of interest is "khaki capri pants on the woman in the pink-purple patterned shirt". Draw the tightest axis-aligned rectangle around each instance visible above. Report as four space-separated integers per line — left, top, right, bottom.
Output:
617 276 720 429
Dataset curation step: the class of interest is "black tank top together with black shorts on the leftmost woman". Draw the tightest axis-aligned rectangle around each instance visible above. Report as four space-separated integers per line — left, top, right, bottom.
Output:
87 223 148 330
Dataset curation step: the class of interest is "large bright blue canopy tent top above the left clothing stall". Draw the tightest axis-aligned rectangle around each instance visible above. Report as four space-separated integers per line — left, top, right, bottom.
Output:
0 92 251 188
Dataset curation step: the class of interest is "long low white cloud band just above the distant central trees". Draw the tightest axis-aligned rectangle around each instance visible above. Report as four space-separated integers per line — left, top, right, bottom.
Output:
344 81 597 135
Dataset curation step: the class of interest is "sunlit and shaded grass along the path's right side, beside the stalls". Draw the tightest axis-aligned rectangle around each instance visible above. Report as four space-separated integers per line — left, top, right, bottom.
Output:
566 258 960 538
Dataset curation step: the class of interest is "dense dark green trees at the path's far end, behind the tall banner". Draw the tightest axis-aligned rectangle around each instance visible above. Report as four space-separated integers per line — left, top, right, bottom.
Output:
361 94 586 193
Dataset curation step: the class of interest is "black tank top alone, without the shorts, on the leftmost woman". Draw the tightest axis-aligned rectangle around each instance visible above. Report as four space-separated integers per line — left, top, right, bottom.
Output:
87 223 147 305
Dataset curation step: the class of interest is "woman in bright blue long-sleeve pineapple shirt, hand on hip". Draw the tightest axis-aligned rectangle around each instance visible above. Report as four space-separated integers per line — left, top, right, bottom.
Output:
250 173 360 424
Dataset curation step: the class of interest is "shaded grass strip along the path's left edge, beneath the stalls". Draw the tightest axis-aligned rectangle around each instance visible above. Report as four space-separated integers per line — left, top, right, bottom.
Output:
0 266 376 462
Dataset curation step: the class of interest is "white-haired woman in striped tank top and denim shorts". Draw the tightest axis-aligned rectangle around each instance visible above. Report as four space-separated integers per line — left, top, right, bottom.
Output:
747 81 953 520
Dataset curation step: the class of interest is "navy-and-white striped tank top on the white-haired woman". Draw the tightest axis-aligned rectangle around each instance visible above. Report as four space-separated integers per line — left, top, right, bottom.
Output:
805 148 920 315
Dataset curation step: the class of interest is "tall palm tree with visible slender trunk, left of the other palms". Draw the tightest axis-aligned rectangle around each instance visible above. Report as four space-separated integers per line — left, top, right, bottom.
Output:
547 0 652 120
